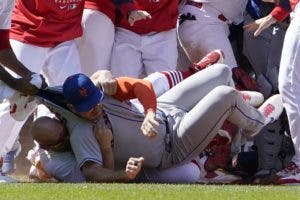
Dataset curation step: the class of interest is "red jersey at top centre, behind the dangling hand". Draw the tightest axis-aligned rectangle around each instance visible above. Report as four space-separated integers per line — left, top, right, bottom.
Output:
117 0 178 34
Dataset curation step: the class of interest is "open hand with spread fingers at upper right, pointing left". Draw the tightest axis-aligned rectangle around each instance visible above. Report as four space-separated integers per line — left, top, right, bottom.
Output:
244 15 276 37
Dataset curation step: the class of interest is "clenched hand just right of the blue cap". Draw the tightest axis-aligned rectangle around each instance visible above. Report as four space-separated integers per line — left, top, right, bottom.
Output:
91 70 117 96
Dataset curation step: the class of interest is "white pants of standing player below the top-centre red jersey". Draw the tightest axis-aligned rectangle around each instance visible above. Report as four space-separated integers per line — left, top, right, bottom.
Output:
111 28 178 78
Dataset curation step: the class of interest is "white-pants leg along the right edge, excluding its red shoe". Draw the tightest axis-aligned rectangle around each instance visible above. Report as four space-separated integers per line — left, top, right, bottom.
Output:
278 9 300 166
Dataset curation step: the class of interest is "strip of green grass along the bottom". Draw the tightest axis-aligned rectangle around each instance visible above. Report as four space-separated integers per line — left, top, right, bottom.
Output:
0 183 300 200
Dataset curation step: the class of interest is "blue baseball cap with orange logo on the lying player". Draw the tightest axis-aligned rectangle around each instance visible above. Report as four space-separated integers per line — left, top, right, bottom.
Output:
63 74 104 112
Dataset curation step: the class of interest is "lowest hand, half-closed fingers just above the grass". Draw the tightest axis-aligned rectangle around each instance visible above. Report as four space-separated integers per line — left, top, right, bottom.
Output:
125 157 144 180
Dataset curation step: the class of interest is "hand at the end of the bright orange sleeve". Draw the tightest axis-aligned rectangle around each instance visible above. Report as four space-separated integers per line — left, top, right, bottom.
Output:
141 110 159 138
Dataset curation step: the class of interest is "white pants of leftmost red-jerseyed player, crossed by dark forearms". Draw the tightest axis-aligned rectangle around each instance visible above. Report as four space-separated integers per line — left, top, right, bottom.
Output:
0 40 80 153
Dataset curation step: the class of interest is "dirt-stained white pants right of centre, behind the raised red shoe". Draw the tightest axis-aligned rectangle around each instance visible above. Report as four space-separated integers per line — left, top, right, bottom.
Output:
178 5 237 69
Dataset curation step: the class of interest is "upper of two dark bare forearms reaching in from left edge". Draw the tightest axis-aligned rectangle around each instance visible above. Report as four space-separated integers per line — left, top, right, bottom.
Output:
0 49 32 77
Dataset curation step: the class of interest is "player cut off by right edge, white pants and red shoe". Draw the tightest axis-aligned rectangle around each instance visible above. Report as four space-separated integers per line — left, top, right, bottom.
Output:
277 0 300 184
